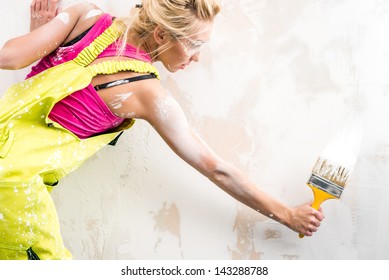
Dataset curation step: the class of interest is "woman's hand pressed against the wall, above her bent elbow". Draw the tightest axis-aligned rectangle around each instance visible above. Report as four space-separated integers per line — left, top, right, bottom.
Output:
30 0 60 31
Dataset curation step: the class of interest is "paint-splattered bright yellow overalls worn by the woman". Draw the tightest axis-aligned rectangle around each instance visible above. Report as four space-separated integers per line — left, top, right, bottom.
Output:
0 20 159 259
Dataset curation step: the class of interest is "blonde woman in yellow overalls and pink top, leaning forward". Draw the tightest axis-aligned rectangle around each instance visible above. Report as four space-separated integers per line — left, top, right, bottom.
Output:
0 0 323 259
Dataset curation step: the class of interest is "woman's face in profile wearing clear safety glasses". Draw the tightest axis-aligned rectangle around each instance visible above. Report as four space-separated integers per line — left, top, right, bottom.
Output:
158 21 213 73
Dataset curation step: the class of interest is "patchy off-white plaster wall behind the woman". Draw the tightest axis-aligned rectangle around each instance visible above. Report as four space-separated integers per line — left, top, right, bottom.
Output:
0 0 389 259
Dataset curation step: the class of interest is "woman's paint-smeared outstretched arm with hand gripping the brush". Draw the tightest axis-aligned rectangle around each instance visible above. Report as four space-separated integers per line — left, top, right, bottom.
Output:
133 82 323 236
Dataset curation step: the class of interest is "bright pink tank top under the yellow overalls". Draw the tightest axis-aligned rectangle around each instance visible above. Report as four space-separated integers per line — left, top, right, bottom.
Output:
27 14 151 139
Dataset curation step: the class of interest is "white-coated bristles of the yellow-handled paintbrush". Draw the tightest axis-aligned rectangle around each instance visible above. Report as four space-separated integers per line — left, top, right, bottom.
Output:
312 157 350 188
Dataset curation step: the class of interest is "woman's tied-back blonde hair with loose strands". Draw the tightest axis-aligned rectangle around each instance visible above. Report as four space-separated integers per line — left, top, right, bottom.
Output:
115 0 221 57
